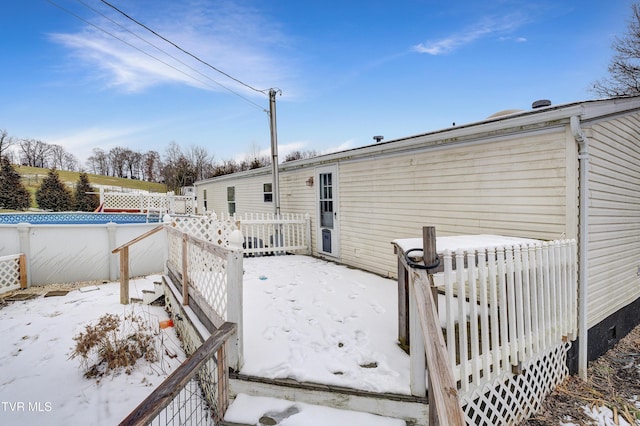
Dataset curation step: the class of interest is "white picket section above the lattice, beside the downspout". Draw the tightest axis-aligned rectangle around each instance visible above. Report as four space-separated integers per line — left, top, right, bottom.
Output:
439 240 578 395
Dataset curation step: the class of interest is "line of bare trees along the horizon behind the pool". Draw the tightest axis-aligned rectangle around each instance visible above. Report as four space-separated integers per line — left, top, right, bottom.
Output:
0 129 318 193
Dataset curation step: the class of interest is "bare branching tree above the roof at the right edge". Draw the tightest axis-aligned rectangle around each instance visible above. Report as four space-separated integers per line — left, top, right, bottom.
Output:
592 3 640 97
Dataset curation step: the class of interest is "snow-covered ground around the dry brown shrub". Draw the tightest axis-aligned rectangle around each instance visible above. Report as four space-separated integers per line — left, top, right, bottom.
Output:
0 276 185 426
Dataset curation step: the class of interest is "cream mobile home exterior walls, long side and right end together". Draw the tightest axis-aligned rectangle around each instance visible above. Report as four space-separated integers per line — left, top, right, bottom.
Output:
197 97 640 359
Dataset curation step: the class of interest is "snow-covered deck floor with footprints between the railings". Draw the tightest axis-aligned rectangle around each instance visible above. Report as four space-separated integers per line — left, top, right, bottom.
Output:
240 255 410 395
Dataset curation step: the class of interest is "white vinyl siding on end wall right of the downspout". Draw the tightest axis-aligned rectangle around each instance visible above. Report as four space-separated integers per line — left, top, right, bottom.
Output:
587 114 640 327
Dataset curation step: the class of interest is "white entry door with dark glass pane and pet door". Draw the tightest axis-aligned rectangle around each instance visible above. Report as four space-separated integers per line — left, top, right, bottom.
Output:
316 166 340 257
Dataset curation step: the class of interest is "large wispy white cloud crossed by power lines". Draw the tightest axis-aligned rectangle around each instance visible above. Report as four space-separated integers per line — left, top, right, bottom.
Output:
50 1 289 95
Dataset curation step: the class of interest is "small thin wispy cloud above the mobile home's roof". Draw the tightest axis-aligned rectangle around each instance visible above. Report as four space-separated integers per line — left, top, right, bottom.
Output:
413 16 524 56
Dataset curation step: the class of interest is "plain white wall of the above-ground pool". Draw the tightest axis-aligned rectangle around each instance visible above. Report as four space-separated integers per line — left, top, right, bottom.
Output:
0 223 167 285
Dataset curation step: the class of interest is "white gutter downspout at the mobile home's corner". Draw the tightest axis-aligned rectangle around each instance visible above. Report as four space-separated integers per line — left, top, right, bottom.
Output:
570 115 589 380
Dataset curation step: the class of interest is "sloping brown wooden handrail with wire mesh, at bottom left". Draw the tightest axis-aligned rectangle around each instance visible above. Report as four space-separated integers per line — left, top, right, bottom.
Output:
120 323 236 426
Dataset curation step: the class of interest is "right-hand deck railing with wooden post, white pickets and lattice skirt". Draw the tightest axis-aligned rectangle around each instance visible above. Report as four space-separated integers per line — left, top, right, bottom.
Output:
396 227 578 425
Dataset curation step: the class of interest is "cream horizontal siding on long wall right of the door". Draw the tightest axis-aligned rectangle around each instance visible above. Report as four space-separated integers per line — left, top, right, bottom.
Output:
338 129 577 276
